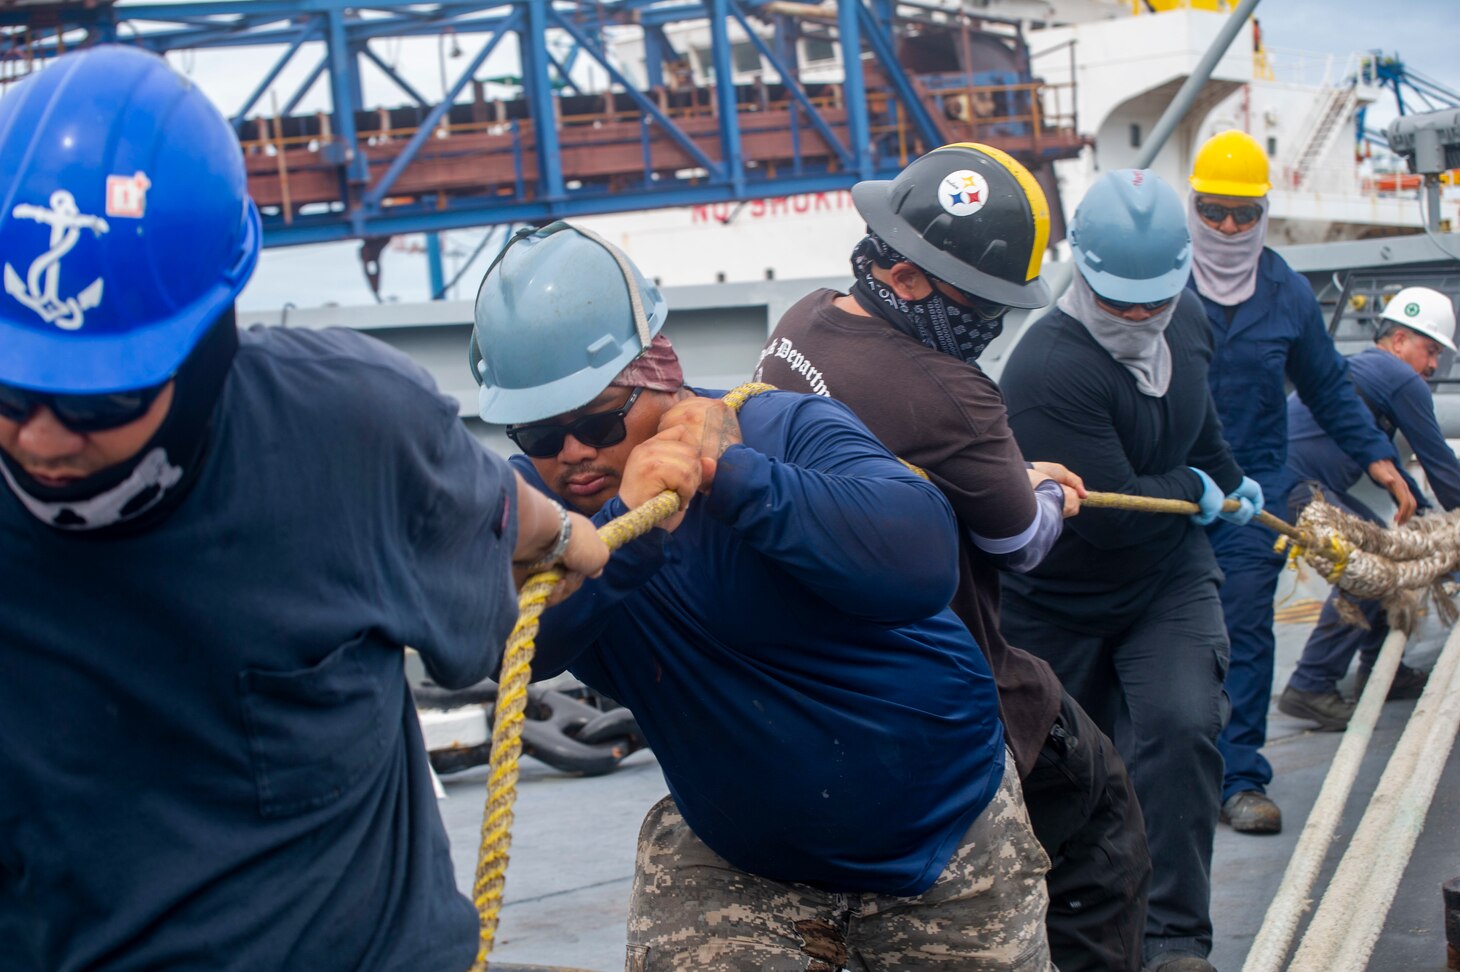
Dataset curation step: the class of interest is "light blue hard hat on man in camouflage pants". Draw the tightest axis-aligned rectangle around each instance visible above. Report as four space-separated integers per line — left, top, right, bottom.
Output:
469 220 669 425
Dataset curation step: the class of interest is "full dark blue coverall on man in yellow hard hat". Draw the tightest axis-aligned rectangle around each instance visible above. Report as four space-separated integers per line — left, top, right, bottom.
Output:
1187 248 1394 801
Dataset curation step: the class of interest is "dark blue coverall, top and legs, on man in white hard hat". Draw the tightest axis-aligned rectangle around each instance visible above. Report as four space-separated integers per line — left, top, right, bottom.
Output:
1288 347 1460 692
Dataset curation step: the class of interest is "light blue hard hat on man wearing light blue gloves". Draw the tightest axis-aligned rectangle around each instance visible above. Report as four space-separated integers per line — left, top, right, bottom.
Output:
1069 169 1191 302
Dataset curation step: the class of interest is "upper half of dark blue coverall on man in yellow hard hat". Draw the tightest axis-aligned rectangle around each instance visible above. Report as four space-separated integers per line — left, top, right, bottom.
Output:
1188 248 1393 496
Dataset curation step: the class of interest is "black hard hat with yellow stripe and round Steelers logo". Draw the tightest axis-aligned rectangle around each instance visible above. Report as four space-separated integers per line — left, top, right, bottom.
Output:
851 142 1050 308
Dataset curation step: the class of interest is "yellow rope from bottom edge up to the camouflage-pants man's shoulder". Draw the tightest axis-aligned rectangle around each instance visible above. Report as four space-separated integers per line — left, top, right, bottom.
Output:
472 382 775 972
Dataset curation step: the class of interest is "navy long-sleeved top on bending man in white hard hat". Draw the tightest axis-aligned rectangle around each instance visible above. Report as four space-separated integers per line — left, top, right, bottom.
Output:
1288 347 1460 509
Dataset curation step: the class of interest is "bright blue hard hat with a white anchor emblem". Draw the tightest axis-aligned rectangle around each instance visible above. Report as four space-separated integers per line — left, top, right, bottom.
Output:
0 45 261 394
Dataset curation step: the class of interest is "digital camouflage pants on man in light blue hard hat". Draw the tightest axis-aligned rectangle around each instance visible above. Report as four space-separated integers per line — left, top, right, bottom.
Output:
625 753 1054 972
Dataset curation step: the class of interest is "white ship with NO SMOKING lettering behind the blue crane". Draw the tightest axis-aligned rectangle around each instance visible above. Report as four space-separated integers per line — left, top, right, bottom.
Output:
575 0 1460 283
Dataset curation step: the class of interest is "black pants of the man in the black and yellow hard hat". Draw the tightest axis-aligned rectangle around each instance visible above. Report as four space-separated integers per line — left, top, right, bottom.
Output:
1023 692 1150 972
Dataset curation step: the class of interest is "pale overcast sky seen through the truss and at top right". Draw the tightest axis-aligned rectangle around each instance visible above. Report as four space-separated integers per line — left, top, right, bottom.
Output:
182 0 1460 308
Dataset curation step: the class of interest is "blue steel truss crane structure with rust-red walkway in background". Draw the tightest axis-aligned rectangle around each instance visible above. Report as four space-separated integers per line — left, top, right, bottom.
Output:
0 0 1083 247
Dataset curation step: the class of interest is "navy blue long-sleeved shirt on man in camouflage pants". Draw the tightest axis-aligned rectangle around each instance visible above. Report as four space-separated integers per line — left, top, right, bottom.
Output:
512 393 1003 895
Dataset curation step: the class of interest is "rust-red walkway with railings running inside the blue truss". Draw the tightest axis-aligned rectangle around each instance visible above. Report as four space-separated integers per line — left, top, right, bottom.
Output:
241 71 1080 223
